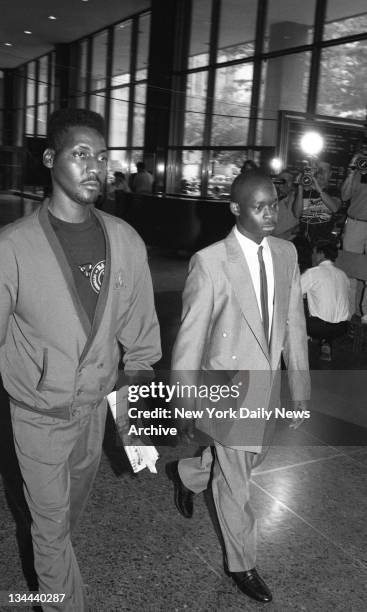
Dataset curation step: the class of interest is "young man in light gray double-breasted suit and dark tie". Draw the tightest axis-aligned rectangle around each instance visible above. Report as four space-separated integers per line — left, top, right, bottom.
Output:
168 171 310 602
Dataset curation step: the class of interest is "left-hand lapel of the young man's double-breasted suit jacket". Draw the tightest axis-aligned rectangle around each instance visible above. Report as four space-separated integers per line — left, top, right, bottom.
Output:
224 230 270 361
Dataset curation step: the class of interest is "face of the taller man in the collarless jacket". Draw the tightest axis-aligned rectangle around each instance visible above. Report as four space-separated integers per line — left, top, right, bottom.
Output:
45 126 107 205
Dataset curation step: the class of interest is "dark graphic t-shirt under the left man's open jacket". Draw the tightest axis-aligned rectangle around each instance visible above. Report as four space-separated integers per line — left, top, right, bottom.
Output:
49 212 106 322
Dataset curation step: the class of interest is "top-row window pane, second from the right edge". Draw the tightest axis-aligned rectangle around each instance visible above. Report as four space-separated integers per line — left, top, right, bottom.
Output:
264 0 315 51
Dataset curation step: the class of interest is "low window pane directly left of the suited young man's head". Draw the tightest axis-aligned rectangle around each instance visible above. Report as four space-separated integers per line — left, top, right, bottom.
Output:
208 150 246 200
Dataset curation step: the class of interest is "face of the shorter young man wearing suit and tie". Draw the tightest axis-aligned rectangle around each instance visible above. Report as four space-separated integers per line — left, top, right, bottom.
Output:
237 181 278 243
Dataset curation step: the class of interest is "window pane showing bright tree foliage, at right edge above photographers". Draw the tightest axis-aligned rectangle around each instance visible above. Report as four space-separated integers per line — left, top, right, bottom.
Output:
316 40 367 120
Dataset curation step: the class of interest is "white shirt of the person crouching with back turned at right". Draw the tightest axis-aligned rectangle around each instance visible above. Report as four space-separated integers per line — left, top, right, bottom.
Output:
301 259 350 323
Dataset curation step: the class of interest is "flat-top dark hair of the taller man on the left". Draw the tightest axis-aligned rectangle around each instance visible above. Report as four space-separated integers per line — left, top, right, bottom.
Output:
47 108 106 151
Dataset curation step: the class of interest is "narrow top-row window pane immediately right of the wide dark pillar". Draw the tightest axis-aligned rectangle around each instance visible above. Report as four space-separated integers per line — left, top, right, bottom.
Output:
189 0 212 68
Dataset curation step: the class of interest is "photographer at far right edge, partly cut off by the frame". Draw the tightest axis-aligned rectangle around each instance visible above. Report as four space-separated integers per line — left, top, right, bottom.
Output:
341 137 367 324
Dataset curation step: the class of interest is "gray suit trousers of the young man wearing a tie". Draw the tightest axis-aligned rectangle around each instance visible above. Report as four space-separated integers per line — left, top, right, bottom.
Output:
178 442 265 572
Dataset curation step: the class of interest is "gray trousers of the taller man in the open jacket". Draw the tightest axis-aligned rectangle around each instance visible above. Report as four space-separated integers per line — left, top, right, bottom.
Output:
10 400 107 612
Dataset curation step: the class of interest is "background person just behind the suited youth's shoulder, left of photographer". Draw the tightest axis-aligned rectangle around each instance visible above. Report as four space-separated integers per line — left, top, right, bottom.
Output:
273 170 299 240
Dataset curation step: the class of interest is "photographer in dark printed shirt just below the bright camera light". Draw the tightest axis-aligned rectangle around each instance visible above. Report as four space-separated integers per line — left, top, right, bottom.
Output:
293 161 341 245
